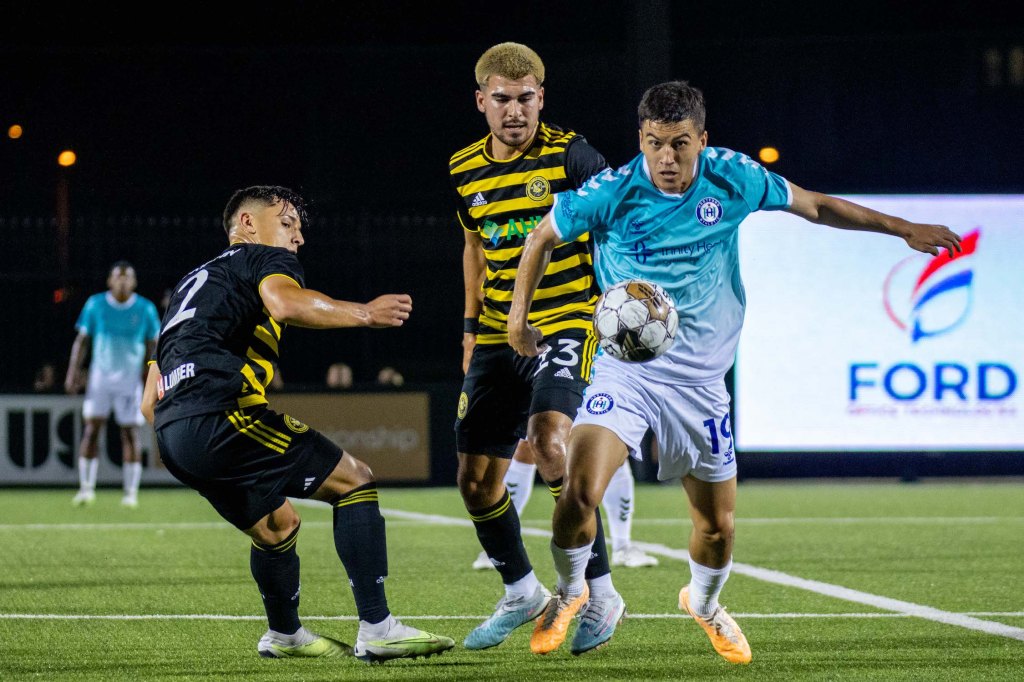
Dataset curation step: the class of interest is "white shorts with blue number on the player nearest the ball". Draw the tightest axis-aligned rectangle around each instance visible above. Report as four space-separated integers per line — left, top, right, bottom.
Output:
573 363 736 483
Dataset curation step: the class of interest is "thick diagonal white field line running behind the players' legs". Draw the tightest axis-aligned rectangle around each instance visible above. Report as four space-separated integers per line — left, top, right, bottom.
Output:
372 501 1024 641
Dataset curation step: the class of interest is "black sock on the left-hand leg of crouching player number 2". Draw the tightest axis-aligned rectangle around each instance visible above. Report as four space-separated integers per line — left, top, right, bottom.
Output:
249 526 302 635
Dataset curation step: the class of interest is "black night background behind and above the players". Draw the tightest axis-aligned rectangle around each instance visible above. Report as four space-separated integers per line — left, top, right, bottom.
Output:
0 0 1024 390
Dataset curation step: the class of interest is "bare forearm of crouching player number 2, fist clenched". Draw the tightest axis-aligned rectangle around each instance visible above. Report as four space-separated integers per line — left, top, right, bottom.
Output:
259 276 413 329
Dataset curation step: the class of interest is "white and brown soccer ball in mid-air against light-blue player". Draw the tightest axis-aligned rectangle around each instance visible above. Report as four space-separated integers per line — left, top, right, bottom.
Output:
594 280 679 363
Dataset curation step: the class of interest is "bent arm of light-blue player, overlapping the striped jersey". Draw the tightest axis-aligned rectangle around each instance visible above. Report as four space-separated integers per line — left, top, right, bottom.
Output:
509 212 561 357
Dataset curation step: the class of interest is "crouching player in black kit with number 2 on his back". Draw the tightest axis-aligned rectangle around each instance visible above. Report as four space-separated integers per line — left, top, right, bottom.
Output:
142 186 455 663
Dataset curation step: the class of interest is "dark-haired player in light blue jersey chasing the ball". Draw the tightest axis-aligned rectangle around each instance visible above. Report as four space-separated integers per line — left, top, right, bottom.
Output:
509 81 959 664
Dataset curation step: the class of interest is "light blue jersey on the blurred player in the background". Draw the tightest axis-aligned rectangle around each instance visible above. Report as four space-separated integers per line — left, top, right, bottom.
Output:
75 292 160 385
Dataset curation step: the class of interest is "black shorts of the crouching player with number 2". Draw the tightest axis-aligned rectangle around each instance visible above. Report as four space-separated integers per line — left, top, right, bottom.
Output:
157 407 342 530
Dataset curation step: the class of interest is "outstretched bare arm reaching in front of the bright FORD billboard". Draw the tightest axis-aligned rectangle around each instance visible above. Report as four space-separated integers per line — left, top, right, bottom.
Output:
787 182 961 257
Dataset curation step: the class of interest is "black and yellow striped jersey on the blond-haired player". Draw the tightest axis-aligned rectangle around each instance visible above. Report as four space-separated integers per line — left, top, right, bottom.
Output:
449 123 607 344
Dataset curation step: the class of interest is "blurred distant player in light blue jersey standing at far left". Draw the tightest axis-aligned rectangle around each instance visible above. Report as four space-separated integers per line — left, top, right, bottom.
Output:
65 261 160 508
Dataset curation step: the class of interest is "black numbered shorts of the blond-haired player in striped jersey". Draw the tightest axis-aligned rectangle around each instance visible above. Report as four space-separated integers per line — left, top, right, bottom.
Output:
455 329 597 458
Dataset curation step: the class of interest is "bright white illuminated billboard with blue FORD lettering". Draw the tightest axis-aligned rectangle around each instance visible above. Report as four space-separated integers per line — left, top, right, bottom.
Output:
734 195 1024 452
